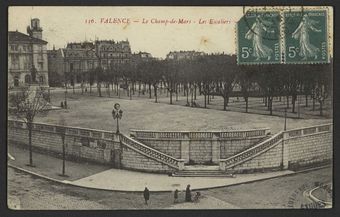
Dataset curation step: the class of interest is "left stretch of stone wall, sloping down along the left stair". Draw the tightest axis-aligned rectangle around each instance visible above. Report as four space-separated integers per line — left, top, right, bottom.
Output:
7 120 179 173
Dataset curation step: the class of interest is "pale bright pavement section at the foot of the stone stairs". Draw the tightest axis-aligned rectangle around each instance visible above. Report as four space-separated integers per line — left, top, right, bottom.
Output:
71 169 294 191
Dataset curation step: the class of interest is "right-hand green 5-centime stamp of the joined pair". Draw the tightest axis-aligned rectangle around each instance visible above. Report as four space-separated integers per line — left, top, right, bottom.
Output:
283 10 329 63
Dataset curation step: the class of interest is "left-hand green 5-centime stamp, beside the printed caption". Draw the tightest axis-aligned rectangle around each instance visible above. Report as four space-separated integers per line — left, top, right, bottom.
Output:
236 11 281 64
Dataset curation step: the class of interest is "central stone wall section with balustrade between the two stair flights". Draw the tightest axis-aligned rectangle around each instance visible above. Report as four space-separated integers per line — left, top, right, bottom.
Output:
131 128 270 164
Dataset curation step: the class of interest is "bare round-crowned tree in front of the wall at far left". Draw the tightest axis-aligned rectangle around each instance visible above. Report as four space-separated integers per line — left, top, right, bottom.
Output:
9 86 49 166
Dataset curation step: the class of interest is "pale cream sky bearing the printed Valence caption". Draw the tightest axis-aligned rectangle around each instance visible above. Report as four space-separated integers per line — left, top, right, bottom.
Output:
8 6 334 58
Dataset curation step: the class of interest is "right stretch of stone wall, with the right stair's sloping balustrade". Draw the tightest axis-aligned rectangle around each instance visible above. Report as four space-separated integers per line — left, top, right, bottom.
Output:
220 124 333 173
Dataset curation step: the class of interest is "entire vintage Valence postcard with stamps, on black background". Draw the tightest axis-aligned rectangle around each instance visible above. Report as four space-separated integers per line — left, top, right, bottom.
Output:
7 6 334 210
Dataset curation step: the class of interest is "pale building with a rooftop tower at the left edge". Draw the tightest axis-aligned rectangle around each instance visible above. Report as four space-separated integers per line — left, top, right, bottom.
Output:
8 18 48 89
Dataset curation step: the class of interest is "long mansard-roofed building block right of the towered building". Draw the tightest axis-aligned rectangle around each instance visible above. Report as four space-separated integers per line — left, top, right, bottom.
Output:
48 40 132 86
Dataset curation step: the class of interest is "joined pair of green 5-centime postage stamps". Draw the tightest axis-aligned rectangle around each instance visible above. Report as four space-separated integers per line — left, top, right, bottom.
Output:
236 8 329 64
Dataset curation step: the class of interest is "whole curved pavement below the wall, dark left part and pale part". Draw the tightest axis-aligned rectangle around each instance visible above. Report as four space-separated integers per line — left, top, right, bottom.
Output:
8 145 294 191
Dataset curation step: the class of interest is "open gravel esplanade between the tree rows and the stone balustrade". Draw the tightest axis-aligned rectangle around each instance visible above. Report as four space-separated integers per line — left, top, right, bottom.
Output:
17 89 332 133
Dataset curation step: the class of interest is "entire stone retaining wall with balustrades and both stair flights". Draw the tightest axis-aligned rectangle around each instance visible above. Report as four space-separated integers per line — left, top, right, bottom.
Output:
7 120 333 173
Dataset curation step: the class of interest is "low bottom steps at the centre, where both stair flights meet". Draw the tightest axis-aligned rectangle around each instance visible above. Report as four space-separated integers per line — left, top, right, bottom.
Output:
172 165 234 177
